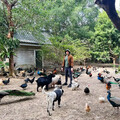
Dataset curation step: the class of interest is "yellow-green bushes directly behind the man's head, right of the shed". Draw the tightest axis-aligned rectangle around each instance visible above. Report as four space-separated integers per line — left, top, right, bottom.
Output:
42 35 91 63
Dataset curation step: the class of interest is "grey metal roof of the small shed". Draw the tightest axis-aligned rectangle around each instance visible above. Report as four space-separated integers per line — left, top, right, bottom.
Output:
14 30 51 44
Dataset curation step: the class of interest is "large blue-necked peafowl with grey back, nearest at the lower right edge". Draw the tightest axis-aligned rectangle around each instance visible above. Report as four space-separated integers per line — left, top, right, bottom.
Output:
107 90 120 113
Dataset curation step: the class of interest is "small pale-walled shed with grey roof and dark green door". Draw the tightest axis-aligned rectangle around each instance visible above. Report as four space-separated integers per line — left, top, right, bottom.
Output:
14 31 51 68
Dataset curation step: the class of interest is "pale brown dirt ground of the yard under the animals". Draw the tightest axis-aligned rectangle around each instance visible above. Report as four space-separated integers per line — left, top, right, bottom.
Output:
0 68 120 120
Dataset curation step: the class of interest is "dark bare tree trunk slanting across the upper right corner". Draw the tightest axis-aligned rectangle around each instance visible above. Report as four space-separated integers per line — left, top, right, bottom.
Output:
95 0 120 31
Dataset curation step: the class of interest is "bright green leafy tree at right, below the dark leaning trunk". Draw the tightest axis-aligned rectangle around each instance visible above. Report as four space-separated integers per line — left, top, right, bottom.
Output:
90 12 120 62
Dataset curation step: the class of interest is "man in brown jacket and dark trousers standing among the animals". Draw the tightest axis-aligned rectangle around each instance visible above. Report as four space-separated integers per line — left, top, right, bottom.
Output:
61 49 73 87
